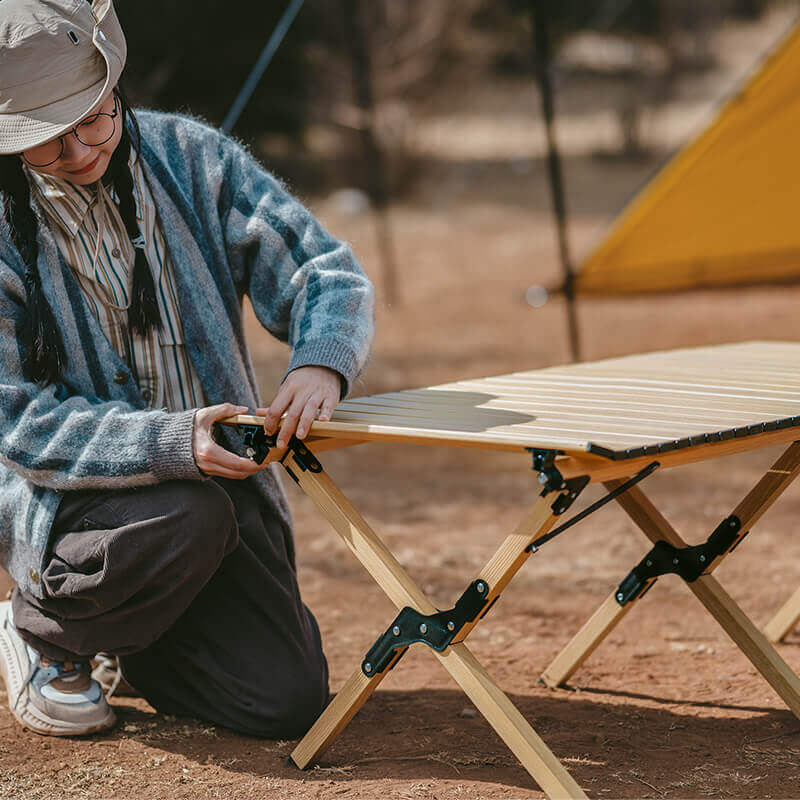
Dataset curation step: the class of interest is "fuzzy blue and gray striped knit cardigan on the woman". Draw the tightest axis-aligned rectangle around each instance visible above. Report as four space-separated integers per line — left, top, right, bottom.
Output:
0 111 374 597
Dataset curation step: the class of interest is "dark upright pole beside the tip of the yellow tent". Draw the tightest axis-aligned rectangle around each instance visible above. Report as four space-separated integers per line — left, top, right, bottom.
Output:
530 0 581 361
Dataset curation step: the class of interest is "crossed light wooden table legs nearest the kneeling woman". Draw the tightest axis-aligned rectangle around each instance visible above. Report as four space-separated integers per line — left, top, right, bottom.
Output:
285 456 586 798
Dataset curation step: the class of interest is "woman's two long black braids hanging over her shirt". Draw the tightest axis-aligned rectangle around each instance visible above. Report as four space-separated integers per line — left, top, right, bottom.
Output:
0 86 161 384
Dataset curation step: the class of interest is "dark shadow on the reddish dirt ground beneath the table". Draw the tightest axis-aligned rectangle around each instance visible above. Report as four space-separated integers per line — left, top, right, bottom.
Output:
104 689 800 798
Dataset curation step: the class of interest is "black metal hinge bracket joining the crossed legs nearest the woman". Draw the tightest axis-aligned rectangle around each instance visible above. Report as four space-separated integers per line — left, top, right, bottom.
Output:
361 580 488 678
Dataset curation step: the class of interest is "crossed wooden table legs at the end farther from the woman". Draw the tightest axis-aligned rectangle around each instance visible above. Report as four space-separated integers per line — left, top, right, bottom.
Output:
542 442 800 717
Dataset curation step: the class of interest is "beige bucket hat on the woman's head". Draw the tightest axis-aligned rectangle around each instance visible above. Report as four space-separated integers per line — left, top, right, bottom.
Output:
0 0 127 155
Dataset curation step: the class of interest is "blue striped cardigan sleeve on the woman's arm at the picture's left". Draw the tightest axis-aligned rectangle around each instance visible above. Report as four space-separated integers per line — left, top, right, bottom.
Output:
0 261 204 490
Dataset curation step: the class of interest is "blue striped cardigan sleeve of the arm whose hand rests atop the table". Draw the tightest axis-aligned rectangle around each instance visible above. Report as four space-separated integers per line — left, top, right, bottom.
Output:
220 137 374 404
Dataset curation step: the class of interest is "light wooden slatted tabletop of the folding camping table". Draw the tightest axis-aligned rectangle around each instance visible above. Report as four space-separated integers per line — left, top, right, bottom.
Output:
280 342 800 459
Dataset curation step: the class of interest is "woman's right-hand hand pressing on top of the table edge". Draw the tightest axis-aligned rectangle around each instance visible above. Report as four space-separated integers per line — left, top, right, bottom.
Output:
257 367 342 448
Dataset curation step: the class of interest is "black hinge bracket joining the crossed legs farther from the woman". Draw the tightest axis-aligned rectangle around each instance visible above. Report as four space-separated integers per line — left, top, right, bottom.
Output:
615 515 743 606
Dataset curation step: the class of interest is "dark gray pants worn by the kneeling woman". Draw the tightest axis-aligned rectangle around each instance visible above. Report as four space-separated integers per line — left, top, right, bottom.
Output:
12 478 328 738
